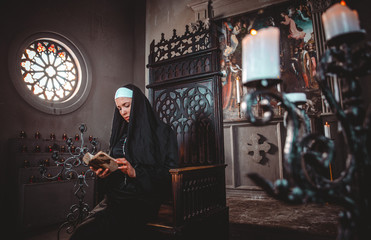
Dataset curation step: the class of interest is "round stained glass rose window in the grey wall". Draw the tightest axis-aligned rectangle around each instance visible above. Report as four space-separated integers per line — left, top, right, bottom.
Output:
20 40 79 102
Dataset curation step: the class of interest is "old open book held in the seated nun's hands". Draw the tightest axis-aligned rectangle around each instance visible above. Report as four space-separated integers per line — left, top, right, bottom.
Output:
82 151 118 172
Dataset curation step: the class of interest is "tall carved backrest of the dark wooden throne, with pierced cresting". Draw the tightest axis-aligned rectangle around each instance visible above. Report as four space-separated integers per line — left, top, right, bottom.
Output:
147 21 224 166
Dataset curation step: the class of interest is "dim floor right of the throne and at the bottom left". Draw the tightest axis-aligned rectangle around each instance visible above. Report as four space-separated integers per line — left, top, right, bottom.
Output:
24 193 340 240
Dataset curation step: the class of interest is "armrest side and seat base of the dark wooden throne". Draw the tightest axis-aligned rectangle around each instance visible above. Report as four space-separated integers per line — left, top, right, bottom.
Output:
147 164 228 239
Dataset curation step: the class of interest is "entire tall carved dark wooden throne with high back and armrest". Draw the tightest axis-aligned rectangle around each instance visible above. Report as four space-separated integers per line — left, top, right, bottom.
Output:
147 18 228 239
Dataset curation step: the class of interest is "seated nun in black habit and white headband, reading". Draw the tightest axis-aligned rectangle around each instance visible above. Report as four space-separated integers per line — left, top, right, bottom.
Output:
70 84 178 240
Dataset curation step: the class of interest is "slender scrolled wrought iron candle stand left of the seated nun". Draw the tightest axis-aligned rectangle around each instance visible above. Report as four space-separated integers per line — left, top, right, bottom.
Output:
40 124 98 239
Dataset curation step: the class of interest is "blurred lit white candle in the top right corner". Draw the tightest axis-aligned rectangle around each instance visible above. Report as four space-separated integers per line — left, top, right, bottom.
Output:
322 3 360 40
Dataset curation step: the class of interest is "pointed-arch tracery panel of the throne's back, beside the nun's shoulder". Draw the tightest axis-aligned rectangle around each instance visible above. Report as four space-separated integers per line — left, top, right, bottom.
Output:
153 79 217 166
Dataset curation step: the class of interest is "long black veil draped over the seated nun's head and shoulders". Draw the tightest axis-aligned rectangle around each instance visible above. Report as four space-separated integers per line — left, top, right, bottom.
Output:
110 84 178 168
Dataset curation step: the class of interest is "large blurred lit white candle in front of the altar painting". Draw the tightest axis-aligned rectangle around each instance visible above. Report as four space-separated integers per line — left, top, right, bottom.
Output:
242 27 281 83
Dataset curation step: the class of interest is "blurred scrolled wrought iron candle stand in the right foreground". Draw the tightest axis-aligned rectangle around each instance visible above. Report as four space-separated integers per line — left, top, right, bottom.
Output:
244 32 371 240
